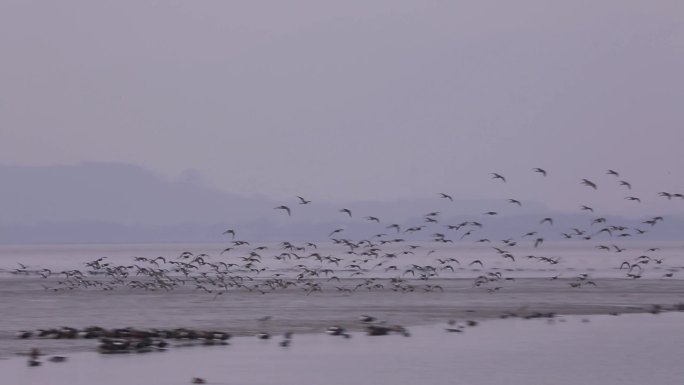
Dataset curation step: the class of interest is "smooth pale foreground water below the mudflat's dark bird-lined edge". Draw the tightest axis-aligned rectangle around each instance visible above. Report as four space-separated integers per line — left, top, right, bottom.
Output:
0 313 684 385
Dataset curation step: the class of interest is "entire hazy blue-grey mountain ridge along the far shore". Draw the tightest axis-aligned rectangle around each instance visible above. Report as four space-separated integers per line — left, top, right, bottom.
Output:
0 162 684 243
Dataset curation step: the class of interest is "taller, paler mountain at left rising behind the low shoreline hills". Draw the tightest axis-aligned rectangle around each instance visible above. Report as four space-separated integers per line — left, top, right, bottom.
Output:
0 163 272 226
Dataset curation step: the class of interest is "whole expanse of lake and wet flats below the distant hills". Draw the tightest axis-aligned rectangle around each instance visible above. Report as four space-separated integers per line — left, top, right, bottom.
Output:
0 242 684 385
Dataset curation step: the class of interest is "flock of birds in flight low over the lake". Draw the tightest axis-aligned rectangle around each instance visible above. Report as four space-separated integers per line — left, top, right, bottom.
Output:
6 168 684 299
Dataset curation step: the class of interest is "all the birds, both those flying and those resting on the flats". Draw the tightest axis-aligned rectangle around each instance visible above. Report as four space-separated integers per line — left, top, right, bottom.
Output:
12 168 684 384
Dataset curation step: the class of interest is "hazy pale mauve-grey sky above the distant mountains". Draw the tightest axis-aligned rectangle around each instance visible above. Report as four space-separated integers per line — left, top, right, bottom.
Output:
0 0 684 212
